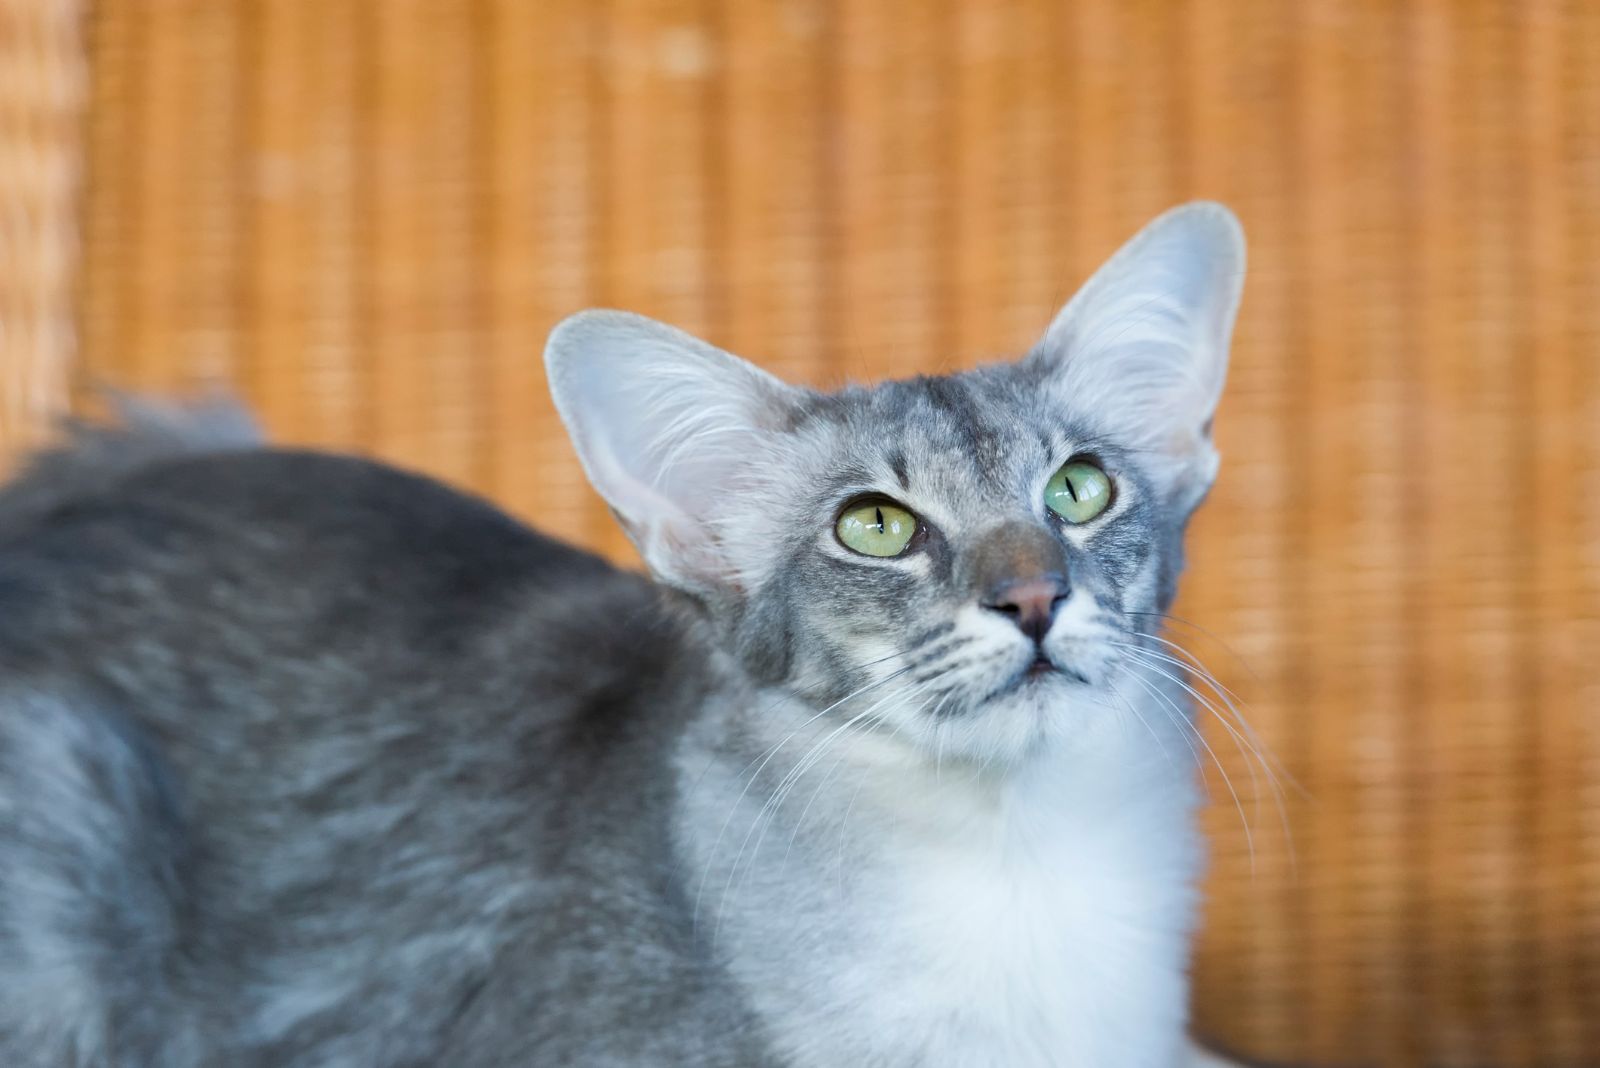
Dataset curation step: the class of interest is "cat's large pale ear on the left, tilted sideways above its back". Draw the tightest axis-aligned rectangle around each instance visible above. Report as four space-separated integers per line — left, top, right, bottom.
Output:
544 310 802 593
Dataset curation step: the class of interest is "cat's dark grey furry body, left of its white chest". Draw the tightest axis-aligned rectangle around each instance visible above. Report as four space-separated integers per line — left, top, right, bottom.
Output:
0 425 748 1065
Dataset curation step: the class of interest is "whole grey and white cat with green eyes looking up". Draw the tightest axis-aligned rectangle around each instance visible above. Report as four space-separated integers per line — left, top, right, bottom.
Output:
0 203 1245 1068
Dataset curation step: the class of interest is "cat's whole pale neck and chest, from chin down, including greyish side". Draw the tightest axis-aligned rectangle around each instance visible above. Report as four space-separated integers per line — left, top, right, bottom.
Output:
678 671 1198 1068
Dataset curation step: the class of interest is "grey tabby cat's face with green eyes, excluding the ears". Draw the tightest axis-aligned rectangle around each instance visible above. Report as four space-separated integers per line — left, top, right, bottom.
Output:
725 365 1195 767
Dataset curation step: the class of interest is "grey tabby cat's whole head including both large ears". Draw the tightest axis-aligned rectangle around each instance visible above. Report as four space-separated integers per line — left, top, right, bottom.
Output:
546 203 1245 759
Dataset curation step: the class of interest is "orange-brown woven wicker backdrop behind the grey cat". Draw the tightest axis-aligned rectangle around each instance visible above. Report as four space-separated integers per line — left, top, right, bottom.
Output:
0 0 1600 1068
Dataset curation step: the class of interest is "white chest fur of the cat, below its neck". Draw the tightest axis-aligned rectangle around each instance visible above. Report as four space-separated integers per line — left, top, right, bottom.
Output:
681 716 1200 1068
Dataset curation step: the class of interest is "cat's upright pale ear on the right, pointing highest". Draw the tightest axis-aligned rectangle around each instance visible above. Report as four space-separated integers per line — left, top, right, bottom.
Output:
1030 201 1245 481
